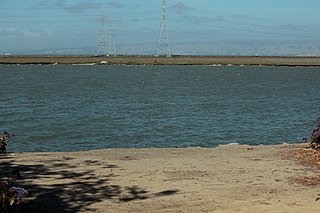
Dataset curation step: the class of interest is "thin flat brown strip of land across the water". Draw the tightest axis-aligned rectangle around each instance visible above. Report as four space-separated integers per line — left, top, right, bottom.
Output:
0 56 320 67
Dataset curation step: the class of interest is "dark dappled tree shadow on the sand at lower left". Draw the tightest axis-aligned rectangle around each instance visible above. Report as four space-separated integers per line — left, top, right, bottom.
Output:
0 154 178 212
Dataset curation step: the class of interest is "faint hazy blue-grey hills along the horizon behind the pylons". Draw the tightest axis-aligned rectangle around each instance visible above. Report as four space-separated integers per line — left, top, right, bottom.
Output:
0 40 320 56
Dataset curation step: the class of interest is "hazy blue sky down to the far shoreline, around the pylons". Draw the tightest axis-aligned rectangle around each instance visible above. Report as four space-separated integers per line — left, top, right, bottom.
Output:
0 0 320 55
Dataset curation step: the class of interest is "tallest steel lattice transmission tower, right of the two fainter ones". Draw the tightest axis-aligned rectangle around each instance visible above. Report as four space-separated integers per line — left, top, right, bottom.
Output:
156 0 171 57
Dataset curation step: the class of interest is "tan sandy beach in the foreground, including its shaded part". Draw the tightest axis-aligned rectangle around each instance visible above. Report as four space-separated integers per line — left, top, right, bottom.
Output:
0 145 320 212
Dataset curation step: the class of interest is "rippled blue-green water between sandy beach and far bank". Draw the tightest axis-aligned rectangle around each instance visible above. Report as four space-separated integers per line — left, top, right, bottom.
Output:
0 65 320 151
